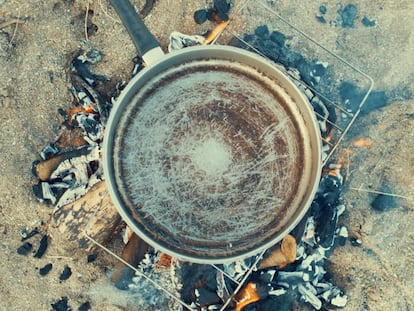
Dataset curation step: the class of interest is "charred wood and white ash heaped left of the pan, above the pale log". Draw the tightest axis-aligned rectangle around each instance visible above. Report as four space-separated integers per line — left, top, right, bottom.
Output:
32 50 122 209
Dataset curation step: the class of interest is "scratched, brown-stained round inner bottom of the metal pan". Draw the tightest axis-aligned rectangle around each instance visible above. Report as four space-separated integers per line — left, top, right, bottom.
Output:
114 59 305 258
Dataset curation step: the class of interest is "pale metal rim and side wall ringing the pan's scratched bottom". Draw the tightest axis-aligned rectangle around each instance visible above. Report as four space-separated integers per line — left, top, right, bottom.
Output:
103 46 321 264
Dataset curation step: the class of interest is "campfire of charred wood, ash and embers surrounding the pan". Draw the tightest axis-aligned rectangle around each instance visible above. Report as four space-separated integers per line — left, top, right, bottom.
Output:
25 1 376 311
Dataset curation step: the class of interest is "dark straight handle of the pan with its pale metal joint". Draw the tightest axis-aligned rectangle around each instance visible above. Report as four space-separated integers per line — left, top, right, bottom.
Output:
110 0 164 64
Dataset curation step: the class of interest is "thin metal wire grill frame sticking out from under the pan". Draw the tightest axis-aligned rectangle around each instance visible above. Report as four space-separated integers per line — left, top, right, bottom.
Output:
84 0 374 311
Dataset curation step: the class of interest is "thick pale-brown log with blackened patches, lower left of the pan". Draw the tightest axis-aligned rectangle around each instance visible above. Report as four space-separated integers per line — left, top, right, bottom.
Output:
51 181 121 251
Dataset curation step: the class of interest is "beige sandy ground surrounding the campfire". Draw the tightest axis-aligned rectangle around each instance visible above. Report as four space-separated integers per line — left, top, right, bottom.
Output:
0 0 414 310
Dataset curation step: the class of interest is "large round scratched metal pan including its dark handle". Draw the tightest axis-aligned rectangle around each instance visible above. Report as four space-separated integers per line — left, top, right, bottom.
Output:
103 0 321 263
